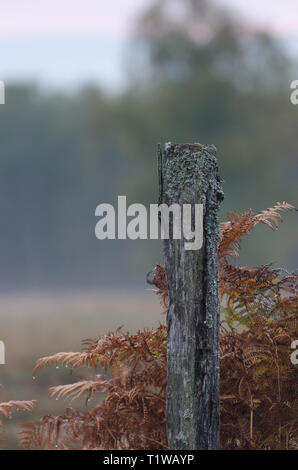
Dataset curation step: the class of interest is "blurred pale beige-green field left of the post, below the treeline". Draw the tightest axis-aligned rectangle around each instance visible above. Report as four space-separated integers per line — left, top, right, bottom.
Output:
0 289 162 449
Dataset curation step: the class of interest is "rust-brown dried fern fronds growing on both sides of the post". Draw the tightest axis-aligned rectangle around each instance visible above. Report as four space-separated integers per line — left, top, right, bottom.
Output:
21 203 298 449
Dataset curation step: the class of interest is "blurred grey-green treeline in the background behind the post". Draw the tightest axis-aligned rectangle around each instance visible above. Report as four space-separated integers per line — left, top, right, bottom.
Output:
0 0 298 290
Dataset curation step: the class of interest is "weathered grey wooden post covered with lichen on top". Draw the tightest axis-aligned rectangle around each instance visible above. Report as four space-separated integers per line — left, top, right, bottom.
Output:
158 143 223 450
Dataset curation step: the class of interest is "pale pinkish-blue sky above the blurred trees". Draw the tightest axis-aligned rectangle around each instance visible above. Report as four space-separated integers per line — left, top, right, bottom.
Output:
0 0 298 91
